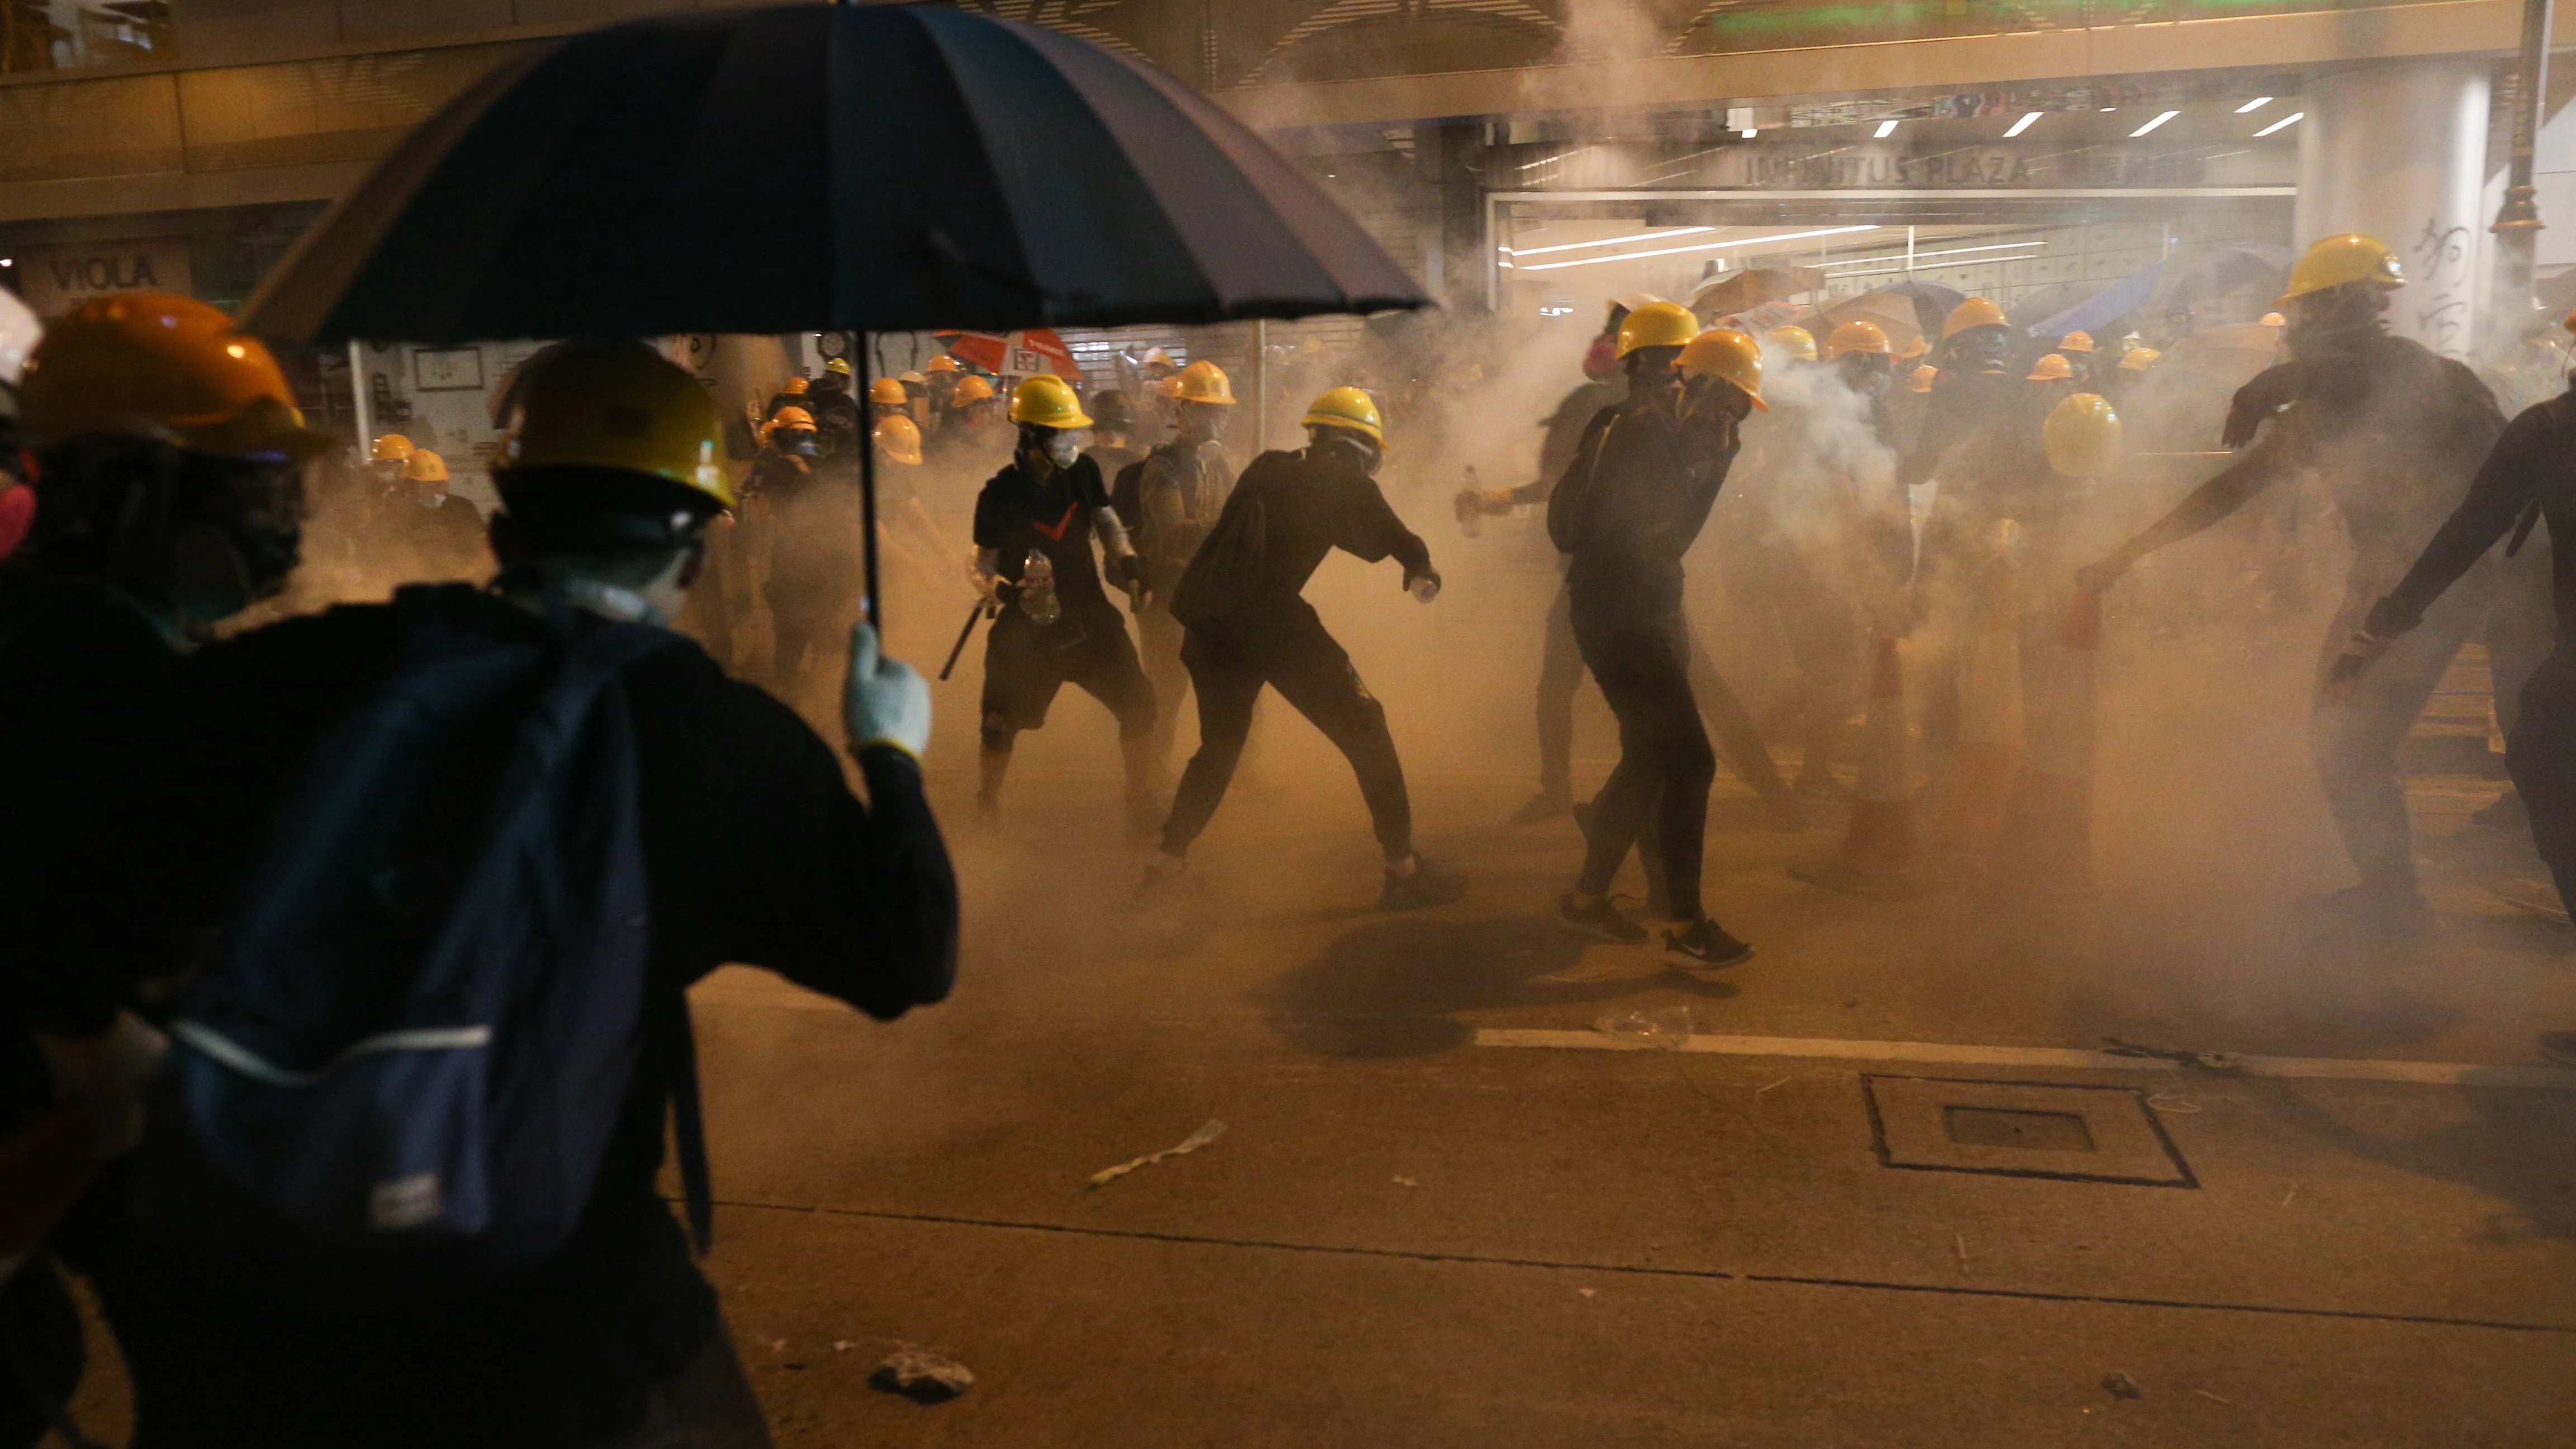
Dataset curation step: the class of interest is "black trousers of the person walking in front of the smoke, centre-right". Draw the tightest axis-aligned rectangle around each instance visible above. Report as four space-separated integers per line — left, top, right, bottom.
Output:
1574 588 1718 921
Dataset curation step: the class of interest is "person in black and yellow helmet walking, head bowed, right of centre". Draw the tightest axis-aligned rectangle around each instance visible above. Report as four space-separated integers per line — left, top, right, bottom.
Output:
1548 304 1762 967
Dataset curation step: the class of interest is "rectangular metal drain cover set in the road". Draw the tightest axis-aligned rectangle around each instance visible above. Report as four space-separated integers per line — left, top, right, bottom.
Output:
1860 1075 2200 1188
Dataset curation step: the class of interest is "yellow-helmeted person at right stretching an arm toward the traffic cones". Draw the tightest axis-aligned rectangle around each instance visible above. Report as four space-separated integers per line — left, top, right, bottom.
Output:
2079 235 2504 936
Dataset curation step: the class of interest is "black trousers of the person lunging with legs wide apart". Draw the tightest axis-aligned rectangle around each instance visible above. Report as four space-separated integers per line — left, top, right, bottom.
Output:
1162 601 1414 861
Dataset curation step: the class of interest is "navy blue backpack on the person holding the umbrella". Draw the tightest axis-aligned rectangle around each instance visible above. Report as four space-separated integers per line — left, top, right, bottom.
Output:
139 585 706 1294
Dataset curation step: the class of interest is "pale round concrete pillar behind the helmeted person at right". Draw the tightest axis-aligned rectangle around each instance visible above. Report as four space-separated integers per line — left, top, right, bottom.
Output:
2298 59 2491 358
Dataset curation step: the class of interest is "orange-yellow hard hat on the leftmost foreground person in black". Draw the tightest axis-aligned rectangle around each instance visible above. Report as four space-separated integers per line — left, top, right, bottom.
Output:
18 291 335 459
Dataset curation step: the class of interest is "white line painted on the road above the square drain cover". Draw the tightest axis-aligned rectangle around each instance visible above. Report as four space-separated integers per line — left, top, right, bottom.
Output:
1476 1029 2576 1091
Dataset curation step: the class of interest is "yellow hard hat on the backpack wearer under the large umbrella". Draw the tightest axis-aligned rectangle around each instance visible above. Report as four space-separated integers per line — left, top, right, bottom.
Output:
503 343 736 508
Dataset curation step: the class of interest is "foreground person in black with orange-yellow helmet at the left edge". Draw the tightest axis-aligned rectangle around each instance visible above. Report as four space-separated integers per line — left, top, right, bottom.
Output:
0 291 332 1441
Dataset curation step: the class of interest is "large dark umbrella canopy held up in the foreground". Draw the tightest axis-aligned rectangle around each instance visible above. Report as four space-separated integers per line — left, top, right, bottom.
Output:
242 5 1427 343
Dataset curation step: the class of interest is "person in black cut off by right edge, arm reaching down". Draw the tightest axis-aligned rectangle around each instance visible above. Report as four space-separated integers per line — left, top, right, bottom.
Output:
2326 351 2576 1065
